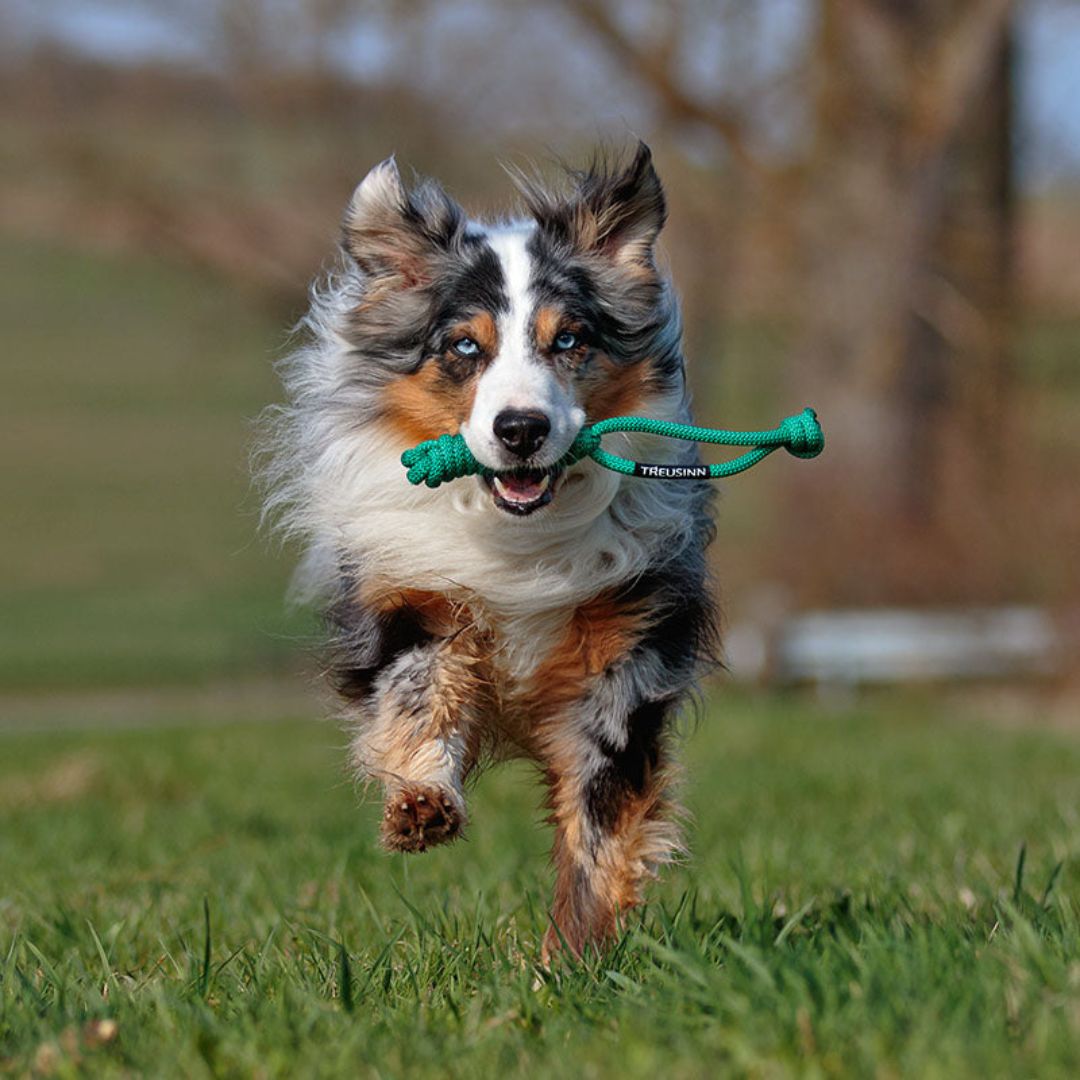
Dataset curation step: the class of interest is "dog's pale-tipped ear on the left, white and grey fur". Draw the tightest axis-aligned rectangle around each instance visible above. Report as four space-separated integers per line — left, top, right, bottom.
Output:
341 158 465 288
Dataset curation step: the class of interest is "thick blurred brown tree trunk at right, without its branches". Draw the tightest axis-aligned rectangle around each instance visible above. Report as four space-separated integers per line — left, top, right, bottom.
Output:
792 0 1011 603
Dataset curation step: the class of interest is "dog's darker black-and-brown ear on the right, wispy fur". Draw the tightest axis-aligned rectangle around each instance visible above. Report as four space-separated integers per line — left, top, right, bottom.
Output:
523 143 667 269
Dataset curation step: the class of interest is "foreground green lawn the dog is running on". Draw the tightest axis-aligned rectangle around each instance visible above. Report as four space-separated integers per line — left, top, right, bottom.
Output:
0 696 1080 1077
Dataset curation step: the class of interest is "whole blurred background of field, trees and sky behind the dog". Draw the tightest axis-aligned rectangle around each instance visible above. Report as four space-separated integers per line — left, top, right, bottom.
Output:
0 0 1080 704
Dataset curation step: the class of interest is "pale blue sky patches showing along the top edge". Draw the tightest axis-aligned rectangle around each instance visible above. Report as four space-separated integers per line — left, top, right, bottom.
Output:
8 0 1080 190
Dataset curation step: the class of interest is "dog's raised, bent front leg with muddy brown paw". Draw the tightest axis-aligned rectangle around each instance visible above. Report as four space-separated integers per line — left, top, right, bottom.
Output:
352 635 486 851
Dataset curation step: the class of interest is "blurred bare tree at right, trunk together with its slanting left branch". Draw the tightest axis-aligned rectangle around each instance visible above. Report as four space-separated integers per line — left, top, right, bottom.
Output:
565 0 1012 595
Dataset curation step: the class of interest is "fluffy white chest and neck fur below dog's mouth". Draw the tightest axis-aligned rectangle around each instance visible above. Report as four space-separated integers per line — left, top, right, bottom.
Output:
308 424 687 626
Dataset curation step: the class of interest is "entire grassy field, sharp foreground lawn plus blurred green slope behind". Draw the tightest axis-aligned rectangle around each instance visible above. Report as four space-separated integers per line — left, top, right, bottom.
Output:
0 238 1080 1077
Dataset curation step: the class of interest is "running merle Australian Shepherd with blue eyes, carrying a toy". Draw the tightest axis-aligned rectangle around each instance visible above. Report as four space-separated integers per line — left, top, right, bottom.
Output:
261 145 715 957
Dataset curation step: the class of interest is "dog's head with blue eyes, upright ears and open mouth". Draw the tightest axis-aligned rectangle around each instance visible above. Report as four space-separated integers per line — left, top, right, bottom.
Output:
343 144 681 515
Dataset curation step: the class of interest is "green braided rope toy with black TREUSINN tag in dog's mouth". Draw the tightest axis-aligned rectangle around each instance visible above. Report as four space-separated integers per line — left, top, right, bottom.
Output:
402 408 825 487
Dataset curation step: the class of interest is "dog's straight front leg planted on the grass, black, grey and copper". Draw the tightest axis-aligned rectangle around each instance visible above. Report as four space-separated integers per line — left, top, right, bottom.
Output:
518 575 713 958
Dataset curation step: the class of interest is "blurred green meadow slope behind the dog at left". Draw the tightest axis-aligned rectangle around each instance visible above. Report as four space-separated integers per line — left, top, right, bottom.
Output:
0 240 308 688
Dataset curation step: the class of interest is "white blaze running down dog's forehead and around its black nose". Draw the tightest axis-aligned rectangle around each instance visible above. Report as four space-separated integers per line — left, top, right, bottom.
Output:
461 222 584 469
